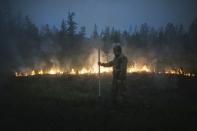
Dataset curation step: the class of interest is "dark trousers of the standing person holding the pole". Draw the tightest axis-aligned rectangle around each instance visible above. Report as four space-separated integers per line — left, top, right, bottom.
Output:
111 80 127 104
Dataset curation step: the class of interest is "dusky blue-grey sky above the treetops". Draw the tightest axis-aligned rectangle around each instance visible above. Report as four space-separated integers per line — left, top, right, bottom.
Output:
12 0 197 33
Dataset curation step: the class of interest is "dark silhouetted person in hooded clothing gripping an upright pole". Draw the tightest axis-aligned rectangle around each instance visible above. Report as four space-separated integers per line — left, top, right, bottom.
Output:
98 45 128 104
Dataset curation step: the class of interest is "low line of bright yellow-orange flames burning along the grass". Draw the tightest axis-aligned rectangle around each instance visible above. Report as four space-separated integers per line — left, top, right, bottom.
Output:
15 64 195 77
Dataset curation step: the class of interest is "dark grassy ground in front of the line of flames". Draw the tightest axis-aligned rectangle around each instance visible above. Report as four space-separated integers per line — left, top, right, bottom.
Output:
0 74 197 131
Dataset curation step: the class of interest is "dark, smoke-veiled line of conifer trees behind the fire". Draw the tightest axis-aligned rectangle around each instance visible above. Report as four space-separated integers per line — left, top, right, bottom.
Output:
0 1 197 71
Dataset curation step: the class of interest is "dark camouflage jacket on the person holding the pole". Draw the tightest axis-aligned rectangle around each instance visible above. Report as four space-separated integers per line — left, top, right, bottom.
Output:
102 55 128 80
